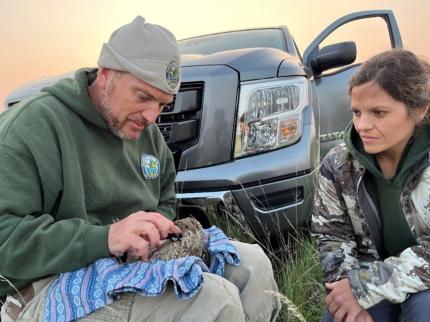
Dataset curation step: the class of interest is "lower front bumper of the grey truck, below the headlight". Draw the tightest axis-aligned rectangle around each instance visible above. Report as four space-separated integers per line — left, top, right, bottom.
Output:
176 171 315 241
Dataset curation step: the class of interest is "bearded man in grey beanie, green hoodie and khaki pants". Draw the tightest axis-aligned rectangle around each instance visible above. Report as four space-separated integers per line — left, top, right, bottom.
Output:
0 17 279 321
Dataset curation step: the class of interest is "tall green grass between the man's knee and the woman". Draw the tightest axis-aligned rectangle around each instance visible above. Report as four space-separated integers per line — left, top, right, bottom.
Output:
209 209 325 322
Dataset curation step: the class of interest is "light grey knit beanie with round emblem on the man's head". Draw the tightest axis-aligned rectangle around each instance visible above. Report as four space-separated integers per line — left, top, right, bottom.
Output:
98 16 181 94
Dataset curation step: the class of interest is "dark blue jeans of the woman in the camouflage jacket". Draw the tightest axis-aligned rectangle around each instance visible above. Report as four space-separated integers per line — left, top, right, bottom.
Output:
322 290 430 322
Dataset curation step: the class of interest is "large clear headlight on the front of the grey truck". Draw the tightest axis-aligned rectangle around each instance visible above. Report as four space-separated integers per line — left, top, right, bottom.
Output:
234 77 308 157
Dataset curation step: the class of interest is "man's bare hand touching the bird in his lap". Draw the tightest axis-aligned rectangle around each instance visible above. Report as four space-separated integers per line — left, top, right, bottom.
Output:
108 211 182 261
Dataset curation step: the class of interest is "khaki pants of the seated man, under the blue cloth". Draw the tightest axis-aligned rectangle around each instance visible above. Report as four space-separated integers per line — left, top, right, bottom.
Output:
1 242 280 322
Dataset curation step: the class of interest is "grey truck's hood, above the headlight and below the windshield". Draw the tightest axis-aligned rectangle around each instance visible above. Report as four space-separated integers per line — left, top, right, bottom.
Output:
181 48 304 81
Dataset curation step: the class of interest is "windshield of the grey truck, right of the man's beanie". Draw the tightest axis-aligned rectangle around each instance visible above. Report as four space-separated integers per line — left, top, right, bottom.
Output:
178 29 286 55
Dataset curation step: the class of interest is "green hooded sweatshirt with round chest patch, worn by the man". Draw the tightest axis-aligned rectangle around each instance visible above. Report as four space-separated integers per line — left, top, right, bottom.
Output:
0 70 175 296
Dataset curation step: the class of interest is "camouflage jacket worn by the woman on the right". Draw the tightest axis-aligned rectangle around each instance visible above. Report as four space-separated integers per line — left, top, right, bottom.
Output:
312 143 430 309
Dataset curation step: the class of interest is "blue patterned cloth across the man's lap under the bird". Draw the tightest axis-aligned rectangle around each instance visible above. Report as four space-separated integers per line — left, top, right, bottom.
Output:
45 226 240 322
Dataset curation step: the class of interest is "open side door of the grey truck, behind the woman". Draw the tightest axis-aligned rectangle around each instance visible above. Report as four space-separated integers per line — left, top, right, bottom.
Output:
303 10 403 155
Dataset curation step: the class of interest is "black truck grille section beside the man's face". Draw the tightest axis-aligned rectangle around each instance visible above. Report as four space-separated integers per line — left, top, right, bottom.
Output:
156 82 204 167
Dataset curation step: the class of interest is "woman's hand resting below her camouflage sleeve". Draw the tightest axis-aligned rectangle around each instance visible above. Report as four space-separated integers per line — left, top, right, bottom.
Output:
325 278 372 322
